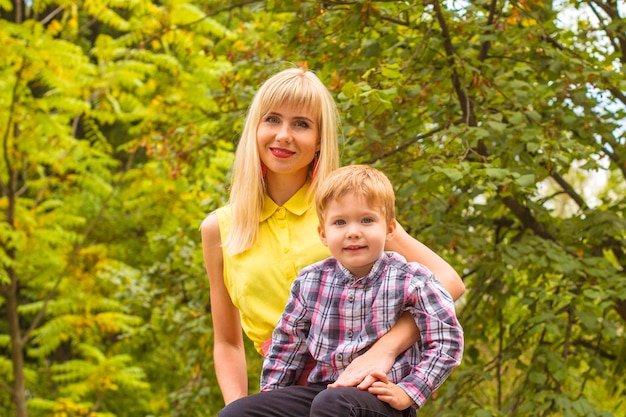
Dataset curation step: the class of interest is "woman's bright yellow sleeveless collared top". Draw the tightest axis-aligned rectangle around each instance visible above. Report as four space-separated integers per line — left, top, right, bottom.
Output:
214 182 330 353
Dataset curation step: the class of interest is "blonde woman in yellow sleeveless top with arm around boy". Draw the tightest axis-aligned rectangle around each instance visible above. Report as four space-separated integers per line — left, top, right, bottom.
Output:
200 68 465 404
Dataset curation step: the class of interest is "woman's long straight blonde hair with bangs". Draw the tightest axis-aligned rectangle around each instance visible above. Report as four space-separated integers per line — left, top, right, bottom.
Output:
224 68 339 255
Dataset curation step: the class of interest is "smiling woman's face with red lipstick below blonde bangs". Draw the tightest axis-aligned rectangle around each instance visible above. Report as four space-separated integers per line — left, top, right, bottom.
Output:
256 106 320 180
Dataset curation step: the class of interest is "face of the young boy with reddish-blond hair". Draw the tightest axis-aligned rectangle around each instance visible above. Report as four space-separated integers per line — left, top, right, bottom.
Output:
318 193 396 278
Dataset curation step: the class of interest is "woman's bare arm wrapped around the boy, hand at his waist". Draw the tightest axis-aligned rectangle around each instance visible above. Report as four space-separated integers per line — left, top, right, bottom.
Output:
329 218 465 389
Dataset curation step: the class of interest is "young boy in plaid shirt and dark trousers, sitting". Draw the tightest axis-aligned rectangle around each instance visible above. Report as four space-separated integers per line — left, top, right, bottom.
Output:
219 165 463 417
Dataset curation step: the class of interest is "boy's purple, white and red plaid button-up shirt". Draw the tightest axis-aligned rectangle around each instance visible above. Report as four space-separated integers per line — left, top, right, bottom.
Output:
261 252 463 407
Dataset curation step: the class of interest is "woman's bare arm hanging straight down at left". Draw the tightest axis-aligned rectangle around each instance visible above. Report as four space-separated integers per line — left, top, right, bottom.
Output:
200 214 248 404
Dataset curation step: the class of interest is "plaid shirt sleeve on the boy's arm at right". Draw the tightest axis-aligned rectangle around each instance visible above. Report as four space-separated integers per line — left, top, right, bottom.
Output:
398 268 464 408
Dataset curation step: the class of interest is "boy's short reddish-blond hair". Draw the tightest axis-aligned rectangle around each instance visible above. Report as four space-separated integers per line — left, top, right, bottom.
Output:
315 165 396 225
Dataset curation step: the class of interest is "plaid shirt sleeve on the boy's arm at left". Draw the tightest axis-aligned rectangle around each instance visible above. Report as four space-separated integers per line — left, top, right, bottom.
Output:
261 275 311 391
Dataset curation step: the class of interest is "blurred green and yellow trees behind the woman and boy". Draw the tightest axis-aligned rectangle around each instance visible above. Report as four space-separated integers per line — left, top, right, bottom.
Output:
0 0 626 417
